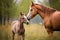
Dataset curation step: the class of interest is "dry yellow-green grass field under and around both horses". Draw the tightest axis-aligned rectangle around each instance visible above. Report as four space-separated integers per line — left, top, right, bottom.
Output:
0 24 60 40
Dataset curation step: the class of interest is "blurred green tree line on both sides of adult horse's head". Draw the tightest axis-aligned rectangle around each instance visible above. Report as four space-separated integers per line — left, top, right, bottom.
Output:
0 0 60 24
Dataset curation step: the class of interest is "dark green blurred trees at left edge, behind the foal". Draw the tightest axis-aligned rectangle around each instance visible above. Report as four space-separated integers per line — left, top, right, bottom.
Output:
0 0 16 24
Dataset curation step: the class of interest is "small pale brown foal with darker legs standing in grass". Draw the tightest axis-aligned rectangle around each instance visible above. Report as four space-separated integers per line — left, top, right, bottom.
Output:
11 13 29 40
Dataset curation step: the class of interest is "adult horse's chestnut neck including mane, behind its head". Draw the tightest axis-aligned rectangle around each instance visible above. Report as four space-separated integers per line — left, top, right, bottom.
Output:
37 5 56 19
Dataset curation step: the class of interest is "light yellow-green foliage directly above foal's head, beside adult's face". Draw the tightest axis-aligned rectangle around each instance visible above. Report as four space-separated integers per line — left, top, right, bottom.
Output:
14 0 31 18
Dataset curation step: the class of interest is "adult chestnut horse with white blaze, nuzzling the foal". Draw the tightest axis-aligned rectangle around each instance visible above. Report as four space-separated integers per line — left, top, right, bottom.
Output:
27 2 60 34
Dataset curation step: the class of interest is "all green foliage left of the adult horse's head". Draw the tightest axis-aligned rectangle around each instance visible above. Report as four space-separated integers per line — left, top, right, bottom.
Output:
0 0 31 24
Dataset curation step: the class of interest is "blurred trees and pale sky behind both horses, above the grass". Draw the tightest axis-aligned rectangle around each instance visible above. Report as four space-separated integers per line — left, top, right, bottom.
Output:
0 0 60 24
